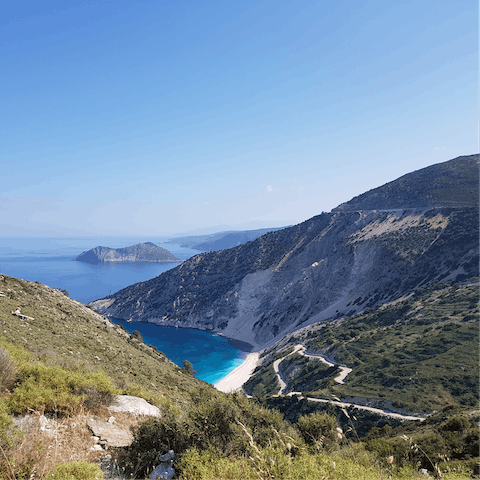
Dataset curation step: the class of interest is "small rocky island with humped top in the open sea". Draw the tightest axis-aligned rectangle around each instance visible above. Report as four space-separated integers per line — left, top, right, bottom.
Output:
73 242 183 264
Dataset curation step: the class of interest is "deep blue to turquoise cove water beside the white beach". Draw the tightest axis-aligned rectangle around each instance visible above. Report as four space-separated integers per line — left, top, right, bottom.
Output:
109 318 247 384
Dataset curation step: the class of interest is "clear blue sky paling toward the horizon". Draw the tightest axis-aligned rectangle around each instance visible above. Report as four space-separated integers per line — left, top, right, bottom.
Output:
0 0 479 239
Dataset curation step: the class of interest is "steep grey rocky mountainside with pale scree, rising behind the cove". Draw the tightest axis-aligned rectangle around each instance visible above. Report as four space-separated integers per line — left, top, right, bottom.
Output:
91 155 479 349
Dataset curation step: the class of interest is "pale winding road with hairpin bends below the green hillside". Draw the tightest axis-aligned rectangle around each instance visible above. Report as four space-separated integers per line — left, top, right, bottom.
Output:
273 345 426 422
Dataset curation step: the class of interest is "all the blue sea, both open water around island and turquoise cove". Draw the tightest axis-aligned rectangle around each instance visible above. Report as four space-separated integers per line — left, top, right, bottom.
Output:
0 237 246 384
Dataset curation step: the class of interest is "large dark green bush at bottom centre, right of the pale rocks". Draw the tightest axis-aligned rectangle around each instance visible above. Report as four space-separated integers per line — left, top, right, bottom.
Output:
117 387 301 479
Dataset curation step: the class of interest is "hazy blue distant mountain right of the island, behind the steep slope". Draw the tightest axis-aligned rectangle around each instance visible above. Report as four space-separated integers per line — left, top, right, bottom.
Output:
168 227 285 252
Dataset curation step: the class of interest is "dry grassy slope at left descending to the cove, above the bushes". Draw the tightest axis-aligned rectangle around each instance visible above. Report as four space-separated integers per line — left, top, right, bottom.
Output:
0 275 204 403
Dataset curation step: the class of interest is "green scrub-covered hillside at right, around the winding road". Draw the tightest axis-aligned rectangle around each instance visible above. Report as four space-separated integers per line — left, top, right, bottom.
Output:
244 278 480 413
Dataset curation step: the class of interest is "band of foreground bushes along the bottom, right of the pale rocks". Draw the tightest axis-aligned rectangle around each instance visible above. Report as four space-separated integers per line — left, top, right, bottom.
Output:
117 388 480 480
